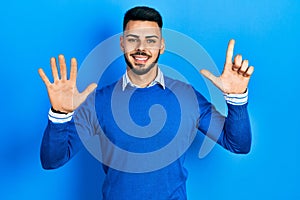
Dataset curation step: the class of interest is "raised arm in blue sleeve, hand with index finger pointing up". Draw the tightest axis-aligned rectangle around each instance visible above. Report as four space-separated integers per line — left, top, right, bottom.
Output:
199 40 254 153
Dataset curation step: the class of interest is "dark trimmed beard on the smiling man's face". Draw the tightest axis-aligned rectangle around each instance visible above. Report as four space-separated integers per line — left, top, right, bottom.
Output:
123 52 160 75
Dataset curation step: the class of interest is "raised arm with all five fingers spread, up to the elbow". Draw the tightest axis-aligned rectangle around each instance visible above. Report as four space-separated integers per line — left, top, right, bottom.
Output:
38 55 97 169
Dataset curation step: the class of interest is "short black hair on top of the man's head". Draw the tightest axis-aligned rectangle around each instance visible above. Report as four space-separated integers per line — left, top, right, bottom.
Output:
123 6 163 31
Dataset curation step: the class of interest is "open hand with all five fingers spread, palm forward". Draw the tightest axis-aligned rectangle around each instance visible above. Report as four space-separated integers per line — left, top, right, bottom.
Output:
38 55 97 113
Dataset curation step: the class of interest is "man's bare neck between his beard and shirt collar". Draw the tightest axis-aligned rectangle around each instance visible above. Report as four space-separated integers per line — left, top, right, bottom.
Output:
127 66 157 88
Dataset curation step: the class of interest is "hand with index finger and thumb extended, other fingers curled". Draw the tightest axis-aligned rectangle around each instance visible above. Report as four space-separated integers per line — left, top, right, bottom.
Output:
200 40 254 94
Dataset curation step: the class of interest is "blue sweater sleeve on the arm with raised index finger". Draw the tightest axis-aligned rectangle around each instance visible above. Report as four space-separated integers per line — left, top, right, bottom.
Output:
196 92 251 154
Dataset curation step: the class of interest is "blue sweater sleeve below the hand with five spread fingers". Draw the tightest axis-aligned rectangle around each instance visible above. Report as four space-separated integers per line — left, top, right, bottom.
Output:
40 92 95 169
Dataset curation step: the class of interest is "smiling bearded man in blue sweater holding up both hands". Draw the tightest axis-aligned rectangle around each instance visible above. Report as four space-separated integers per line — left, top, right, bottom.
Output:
39 7 254 200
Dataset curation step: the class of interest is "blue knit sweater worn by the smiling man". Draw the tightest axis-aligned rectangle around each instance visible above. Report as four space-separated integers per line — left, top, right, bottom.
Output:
41 77 251 200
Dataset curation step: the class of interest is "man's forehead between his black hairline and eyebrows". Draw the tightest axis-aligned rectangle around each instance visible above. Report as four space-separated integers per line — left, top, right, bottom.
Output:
124 20 161 36
